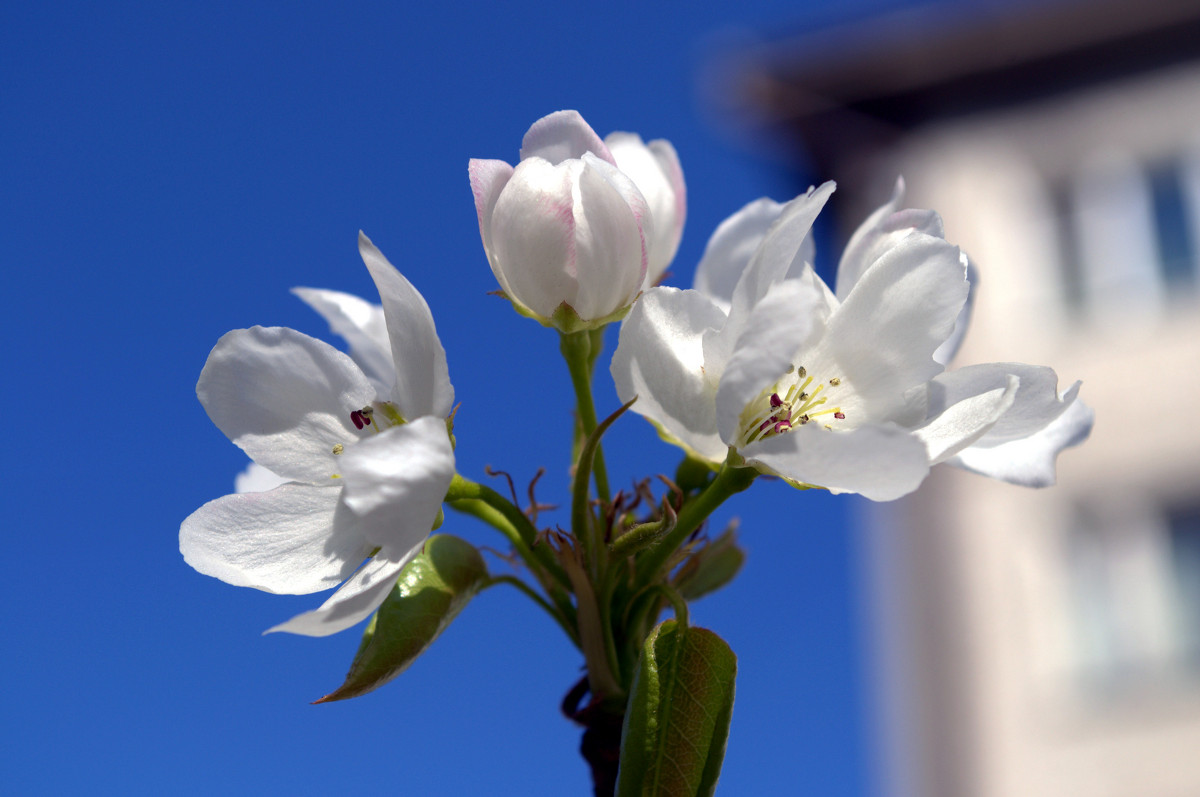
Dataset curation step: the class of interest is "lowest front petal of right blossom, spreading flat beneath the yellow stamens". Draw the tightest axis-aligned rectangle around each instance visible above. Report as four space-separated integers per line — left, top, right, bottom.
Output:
742 423 929 501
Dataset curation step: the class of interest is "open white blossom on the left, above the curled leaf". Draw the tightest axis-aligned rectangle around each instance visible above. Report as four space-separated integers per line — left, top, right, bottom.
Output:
179 234 455 636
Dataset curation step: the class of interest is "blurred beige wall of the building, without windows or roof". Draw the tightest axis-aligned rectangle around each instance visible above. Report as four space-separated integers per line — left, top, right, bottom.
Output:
871 59 1200 797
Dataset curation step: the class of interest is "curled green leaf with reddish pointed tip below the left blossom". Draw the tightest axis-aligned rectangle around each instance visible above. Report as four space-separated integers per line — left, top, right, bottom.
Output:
314 534 487 703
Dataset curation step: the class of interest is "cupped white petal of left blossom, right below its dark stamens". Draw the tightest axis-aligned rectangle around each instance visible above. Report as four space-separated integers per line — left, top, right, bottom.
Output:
341 415 455 550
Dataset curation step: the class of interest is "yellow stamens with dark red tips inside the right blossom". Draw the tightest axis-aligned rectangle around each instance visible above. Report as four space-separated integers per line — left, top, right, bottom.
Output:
740 365 846 447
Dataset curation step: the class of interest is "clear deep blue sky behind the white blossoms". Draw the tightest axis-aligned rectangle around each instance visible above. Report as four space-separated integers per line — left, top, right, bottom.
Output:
0 0 964 796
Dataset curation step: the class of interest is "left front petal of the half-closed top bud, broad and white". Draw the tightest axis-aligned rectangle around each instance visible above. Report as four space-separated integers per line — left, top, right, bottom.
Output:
491 158 583 318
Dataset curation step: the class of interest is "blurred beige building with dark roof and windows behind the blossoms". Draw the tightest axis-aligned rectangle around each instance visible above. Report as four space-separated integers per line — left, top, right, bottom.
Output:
722 0 1200 797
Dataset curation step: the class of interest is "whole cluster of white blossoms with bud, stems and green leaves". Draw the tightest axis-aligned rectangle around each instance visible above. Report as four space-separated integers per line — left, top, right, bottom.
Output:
179 110 1092 793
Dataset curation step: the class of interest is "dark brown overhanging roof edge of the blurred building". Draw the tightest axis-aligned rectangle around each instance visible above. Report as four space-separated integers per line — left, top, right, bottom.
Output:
720 0 1200 127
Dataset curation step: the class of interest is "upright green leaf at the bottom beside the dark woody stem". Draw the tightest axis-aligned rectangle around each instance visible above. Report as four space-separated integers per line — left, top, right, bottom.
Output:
617 619 738 797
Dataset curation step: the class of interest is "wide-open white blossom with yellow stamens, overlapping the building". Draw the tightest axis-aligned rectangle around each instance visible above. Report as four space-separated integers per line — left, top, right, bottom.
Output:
612 182 1092 501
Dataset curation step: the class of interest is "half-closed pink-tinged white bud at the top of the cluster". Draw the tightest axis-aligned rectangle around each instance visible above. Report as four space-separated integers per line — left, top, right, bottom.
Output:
468 110 685 330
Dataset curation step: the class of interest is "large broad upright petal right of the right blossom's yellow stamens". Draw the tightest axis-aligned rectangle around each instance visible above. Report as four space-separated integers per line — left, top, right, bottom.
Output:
824 233 967 410
